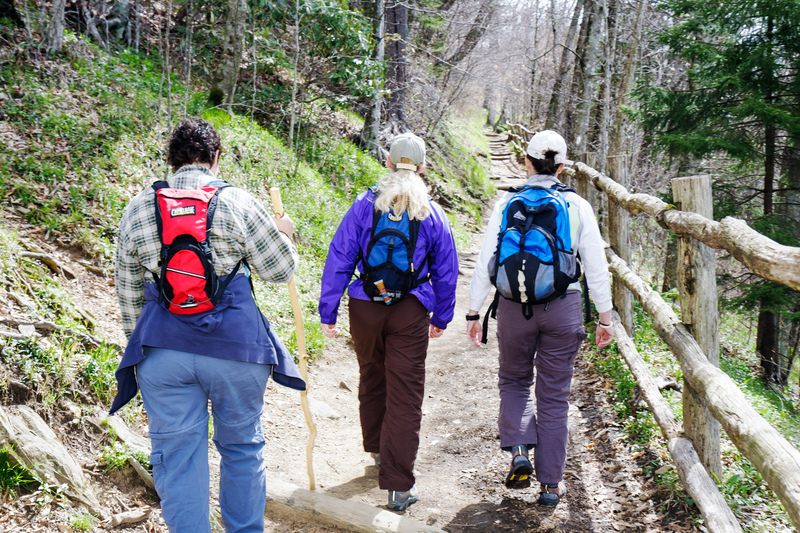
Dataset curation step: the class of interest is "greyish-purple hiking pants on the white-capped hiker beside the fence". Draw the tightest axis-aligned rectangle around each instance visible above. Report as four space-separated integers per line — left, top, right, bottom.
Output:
497 292 586 483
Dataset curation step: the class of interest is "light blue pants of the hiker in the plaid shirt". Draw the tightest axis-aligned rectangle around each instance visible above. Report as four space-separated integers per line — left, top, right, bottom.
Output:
136 347 272 533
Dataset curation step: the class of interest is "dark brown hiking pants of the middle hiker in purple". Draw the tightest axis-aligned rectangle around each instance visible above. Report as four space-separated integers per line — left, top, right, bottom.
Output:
349 295 430 491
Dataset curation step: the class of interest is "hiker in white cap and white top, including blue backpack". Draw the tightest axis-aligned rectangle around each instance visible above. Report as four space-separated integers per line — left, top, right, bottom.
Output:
467 130 614 506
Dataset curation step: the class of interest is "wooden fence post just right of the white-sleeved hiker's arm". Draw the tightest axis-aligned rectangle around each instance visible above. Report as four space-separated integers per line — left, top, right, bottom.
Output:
606 155 634 337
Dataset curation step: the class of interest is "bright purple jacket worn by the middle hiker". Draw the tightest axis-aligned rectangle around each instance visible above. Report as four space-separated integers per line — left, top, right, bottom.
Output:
319 190 458 329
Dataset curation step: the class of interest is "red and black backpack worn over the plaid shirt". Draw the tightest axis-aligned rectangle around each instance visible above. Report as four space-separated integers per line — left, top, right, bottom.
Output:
153 181 242 315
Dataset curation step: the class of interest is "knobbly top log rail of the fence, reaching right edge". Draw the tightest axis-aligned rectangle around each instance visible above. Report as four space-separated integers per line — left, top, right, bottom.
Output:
565 163 800 290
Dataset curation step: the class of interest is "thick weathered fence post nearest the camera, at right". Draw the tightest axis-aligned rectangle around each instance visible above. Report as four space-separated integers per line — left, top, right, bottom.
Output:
672 175 722 478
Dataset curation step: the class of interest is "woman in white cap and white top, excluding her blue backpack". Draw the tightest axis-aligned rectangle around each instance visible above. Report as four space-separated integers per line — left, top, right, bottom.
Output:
467 130 614 506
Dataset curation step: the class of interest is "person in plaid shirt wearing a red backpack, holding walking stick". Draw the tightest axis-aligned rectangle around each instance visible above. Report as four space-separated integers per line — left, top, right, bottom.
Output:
111 118 305 533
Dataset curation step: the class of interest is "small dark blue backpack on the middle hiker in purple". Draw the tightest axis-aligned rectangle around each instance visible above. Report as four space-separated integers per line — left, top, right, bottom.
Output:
359 186 430 305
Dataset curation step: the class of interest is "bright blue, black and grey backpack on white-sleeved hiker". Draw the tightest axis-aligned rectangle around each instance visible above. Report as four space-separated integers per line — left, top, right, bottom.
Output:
483 183 581 343
